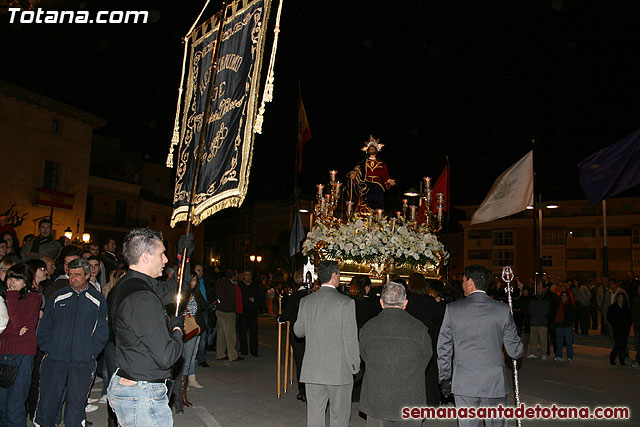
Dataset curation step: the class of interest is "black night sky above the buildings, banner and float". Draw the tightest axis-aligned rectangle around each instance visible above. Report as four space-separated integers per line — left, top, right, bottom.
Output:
0 0 640 214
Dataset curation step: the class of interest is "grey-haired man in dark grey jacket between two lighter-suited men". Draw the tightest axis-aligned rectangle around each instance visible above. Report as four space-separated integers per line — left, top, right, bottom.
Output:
360 282 433 427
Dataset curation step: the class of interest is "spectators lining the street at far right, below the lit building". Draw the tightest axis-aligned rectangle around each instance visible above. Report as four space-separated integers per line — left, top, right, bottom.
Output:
496 271 640 368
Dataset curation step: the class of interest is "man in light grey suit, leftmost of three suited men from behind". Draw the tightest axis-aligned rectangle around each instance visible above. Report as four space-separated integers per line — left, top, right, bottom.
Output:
293 261 360 427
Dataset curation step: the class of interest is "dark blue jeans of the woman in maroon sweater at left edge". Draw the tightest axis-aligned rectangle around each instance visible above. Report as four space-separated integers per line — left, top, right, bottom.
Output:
0 354 33 427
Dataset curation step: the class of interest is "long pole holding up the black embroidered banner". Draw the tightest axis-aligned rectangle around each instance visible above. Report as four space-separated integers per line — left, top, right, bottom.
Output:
175 0 227 317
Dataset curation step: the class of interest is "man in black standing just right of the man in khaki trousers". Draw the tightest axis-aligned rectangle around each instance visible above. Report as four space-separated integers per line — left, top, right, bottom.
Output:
238 271 262 357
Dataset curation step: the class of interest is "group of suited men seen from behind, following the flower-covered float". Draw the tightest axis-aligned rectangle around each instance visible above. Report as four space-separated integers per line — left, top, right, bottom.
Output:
286 261 523 427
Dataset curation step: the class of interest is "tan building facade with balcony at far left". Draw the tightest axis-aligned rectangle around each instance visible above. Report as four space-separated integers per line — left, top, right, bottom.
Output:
0 81 106 241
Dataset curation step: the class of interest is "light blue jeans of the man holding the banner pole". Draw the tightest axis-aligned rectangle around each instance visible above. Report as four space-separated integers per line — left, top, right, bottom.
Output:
107 372 173 427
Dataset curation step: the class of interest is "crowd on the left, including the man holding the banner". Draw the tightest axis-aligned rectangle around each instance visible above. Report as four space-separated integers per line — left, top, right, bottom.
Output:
0 218 286 426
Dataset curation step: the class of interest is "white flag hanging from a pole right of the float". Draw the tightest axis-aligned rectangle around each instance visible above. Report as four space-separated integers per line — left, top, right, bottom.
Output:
471 150 533 225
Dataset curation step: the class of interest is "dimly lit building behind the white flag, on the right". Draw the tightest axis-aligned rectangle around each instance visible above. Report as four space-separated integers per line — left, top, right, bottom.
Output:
458 197 640 281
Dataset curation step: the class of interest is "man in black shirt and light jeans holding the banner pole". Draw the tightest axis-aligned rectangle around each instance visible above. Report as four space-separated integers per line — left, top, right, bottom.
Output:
107 228 184 426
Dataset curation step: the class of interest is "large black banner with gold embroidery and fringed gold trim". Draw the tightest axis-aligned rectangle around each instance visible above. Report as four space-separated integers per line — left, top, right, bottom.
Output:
171 0 271 227
